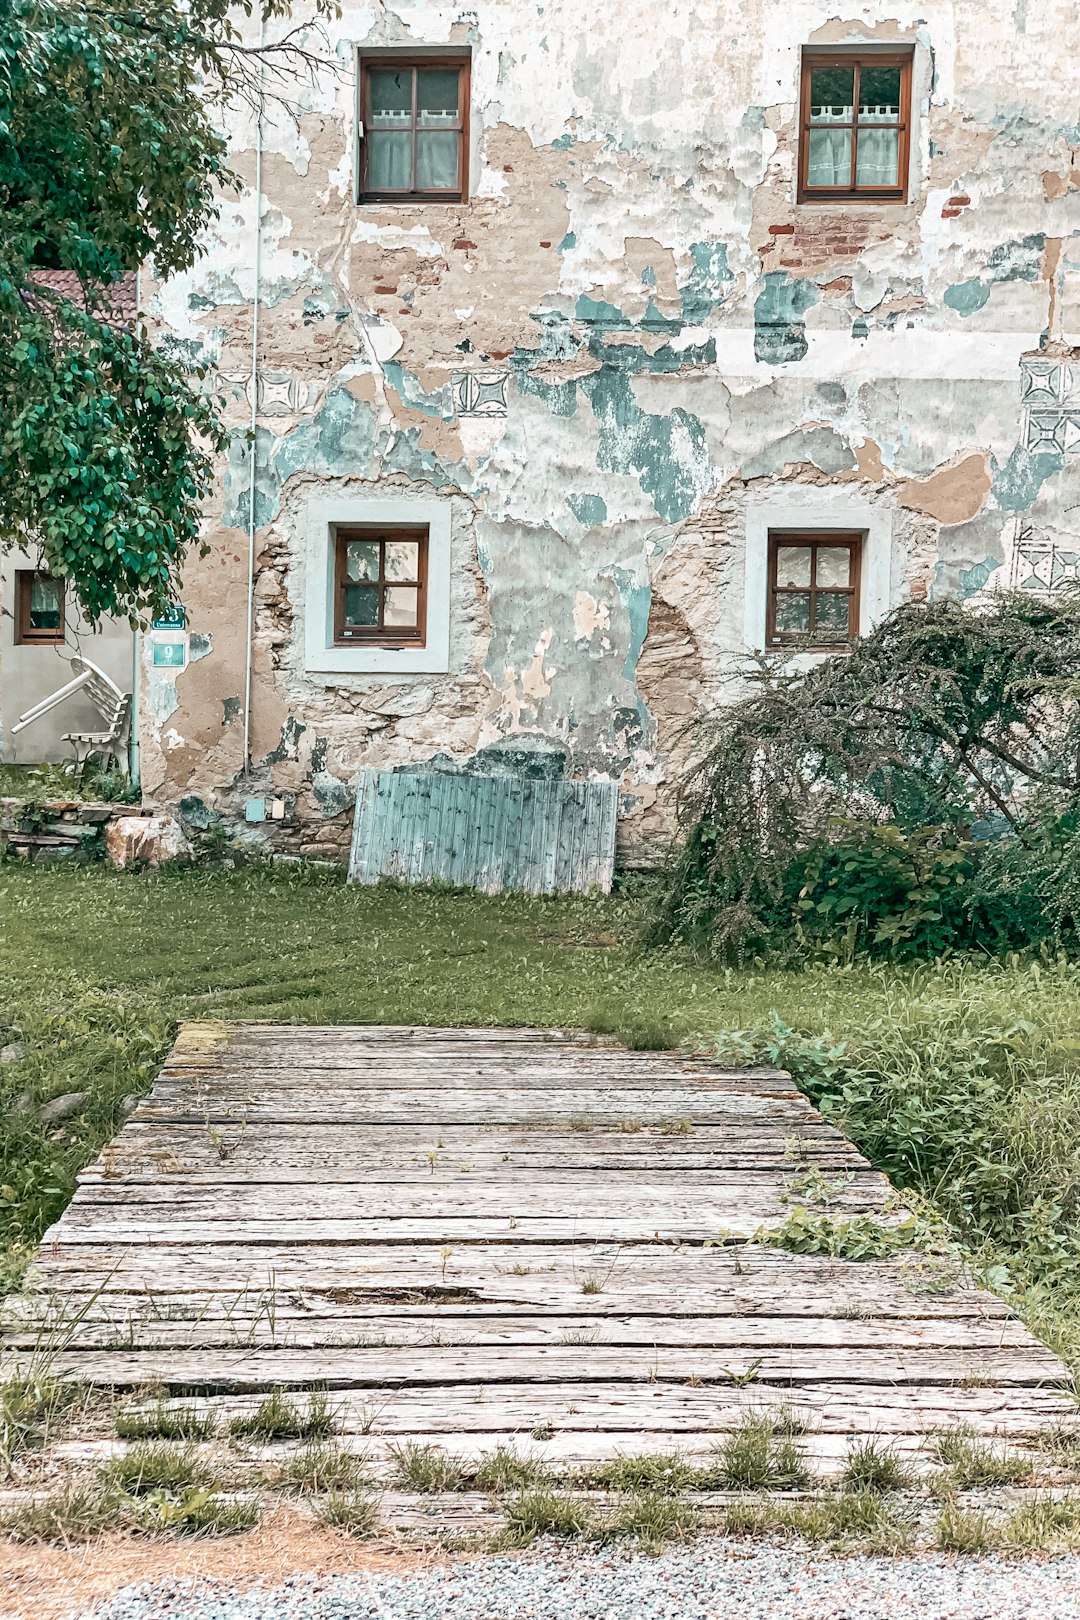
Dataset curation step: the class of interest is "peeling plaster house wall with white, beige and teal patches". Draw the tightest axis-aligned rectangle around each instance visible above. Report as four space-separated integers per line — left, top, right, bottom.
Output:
142 0 1080 859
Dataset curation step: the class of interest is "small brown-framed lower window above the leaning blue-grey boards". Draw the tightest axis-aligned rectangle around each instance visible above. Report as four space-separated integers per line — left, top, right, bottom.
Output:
334 528 427 646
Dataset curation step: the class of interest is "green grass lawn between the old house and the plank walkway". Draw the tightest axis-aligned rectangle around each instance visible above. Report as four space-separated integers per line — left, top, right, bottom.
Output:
0 862 1080 1361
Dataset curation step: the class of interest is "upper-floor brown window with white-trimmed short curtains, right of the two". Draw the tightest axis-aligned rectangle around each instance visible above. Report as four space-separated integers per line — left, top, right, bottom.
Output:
798 52 912 203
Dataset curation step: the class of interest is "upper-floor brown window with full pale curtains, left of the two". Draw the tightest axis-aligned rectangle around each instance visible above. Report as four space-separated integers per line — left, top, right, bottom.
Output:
359 53 470 203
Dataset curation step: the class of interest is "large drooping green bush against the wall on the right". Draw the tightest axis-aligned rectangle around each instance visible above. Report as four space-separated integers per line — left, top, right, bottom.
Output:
651 591 1080 956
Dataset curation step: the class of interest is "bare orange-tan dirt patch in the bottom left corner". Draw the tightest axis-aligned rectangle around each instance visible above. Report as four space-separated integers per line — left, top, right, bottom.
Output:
0 1507 440 1620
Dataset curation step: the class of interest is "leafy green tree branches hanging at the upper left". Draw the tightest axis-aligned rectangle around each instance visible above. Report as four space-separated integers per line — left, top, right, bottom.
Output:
0 0 329 622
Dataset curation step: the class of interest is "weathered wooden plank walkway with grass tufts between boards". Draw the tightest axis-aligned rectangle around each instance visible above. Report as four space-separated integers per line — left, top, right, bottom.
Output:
5 1024 1072 1469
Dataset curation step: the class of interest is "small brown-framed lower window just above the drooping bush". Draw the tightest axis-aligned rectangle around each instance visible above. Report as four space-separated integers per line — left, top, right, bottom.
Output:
766 533 863 648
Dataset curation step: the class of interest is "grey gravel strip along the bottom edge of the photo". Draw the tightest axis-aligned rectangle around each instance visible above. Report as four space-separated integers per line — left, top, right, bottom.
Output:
87 1541 1080 1620
